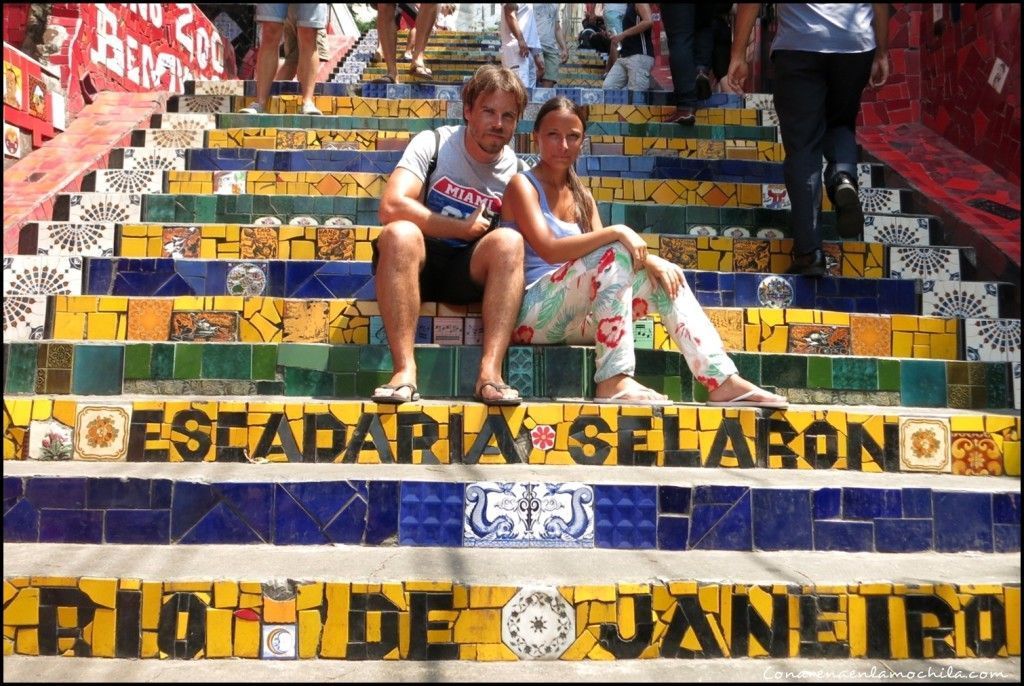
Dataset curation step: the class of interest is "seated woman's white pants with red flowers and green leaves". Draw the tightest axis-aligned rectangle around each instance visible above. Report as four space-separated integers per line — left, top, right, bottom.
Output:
512 243 736 390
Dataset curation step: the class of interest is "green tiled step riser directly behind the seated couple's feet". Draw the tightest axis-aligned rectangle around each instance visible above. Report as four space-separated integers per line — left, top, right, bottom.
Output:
4 341 1014 410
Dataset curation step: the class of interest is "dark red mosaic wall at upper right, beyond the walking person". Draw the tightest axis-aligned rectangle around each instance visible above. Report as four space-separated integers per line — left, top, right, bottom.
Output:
919 3 1021 183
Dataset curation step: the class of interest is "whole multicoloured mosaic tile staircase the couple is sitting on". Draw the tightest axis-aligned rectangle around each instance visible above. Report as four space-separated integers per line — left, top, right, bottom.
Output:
3 29 1020 660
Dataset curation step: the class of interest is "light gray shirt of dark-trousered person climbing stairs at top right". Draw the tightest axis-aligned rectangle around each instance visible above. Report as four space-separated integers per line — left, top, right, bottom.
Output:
771 2 876 52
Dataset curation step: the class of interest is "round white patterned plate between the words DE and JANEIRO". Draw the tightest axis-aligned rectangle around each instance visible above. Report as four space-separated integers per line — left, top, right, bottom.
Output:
502 587 575 659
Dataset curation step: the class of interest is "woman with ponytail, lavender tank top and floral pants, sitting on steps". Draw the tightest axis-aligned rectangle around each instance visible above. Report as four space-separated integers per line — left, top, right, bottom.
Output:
502 96 787 408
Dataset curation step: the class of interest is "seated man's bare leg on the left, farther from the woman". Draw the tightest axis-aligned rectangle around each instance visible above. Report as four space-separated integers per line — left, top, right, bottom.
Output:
376 220 425 393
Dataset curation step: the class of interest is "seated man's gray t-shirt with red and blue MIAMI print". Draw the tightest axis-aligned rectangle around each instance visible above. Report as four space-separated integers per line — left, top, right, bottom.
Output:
397 126 518 246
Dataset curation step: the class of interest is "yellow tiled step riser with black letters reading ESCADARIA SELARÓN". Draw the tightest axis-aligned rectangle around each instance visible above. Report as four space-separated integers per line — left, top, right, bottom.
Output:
4 397 1020 479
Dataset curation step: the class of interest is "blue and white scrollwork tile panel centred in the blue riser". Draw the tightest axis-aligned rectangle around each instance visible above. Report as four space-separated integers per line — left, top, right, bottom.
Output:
463 481 594 548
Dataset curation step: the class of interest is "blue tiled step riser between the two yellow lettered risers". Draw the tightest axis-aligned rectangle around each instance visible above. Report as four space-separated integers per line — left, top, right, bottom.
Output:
3 476 1020 554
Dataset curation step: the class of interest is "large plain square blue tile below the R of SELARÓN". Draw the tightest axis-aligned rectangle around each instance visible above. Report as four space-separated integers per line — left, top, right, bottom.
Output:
751 488 814 550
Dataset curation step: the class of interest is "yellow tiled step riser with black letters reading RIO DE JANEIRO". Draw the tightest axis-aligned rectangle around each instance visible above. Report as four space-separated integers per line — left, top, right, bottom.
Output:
4 576 1021 673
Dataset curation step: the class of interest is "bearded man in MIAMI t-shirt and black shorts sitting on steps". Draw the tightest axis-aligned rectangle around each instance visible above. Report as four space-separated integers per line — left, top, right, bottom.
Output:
373 65 526 405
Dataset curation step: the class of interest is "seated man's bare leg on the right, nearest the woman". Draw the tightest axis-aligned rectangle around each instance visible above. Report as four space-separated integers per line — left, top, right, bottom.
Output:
468 231 524 398
